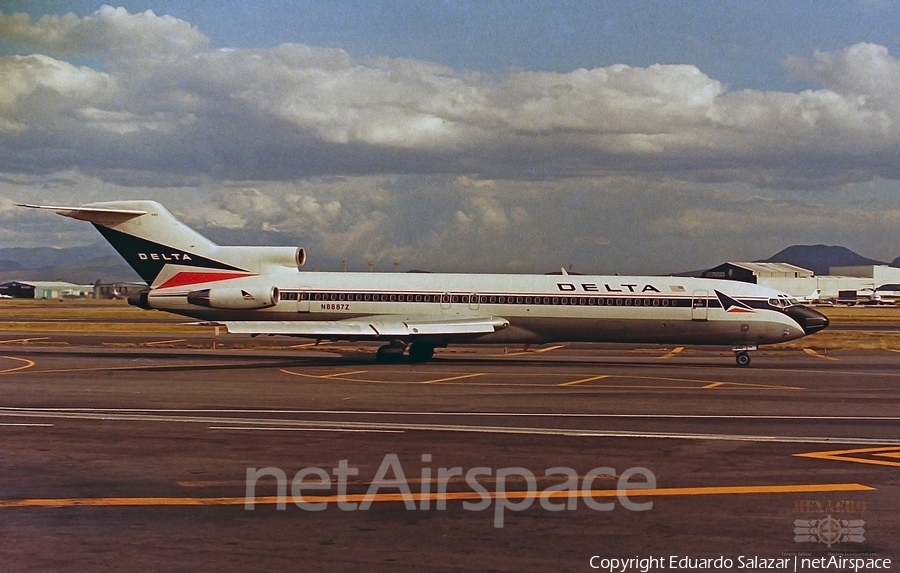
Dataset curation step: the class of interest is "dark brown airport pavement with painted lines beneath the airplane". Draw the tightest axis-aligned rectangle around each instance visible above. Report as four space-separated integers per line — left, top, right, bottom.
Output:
0 333 900 571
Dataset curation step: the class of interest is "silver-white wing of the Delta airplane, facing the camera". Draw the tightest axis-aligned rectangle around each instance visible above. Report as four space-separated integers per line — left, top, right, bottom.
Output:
204 316 509 338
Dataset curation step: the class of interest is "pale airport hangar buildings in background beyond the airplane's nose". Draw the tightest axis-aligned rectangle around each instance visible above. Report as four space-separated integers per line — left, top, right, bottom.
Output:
701 262 900 299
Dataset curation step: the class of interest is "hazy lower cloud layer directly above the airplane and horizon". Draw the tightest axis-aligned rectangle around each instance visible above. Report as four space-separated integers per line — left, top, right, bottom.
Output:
8 172 900 274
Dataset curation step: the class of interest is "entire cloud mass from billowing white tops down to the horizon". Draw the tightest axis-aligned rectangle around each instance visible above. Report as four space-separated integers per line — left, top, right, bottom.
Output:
8 7 900 272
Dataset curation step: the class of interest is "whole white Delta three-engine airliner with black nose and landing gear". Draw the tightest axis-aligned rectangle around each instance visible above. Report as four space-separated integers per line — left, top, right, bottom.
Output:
22 201 828 366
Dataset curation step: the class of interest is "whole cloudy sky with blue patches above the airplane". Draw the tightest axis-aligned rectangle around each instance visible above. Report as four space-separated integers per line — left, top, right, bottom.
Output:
0 0 900 274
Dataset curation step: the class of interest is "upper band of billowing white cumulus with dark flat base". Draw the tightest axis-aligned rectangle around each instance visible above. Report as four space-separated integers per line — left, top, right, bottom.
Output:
0 7 900 188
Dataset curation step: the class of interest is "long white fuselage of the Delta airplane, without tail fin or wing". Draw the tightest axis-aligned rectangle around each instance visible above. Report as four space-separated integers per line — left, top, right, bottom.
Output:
147 269 806 345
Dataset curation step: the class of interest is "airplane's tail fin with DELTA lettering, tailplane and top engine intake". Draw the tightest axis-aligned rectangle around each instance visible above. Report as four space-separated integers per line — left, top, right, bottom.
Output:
22 201 306 284
